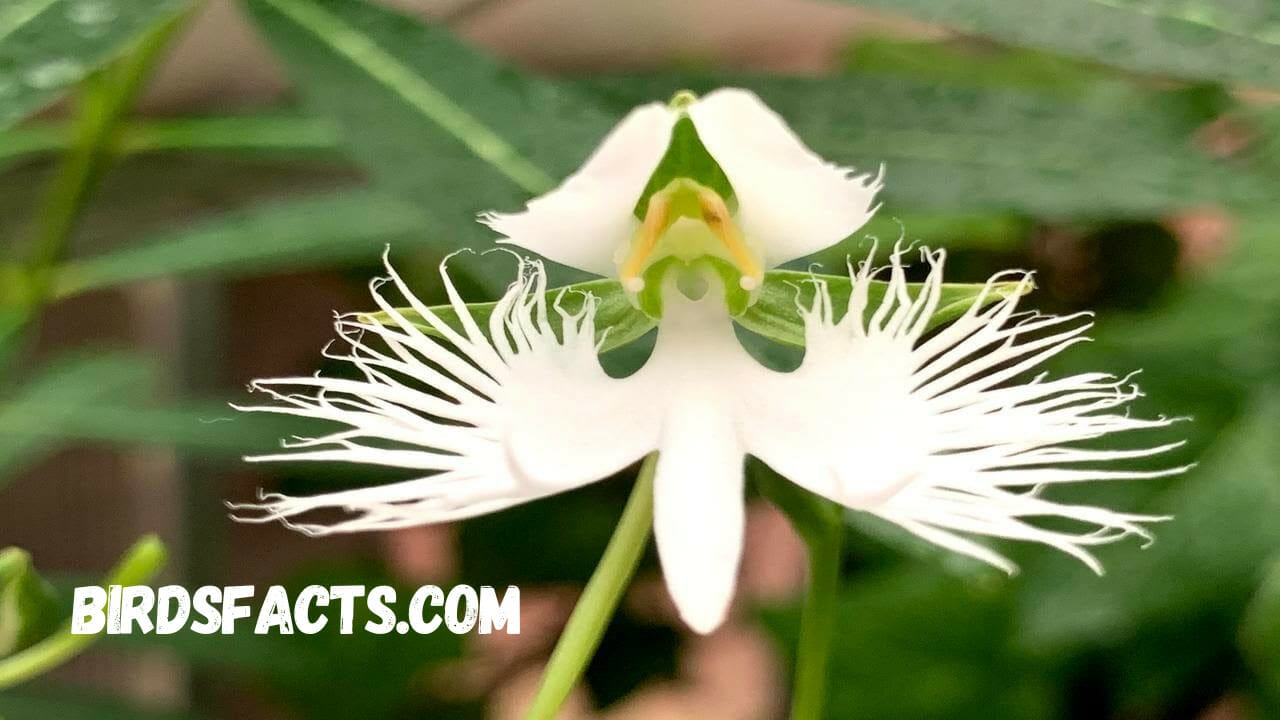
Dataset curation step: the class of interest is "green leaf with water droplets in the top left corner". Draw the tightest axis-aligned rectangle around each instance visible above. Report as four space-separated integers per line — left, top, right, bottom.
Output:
0 0 192 128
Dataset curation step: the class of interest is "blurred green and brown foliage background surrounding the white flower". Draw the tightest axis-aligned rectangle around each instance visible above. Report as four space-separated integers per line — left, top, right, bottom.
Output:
0 0 1280 720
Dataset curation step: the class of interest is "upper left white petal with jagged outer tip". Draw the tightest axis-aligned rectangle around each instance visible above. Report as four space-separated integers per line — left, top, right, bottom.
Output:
481 102 676 275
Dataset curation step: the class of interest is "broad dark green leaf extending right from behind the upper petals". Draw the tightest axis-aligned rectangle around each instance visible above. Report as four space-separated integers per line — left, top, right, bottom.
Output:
582 73 1280 217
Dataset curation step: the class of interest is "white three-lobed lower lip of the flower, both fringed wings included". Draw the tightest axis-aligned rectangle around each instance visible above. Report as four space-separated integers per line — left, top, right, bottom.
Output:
237 251 1183 632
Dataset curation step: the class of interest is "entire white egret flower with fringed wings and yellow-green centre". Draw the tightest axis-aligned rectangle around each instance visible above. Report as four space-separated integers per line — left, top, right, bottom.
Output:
234 91 1184 633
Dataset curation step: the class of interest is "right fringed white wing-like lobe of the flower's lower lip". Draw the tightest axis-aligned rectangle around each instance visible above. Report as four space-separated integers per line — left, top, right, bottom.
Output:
742 245 1185 571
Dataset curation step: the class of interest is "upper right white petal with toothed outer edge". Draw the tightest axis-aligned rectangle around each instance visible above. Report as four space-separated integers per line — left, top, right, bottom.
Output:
689 88 881 266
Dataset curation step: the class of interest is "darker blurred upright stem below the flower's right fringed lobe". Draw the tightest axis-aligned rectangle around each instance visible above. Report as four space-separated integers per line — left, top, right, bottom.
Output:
791 512 845 720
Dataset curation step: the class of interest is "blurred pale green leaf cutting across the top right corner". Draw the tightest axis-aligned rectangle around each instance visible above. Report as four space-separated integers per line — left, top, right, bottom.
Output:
856 0 1280 86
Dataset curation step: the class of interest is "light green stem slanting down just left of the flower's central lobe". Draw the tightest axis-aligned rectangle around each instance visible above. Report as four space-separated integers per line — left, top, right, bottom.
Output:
525 454 658 720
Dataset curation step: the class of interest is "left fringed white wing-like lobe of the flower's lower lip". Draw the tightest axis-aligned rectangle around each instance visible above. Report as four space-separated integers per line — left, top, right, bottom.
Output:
236 254 659 534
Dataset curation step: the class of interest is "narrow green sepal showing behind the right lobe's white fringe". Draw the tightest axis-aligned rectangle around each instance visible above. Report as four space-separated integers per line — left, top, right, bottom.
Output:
736 270 1030 347
